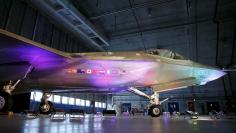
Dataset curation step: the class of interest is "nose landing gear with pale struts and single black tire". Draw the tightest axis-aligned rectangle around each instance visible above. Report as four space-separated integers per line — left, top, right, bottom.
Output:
128 87 168 117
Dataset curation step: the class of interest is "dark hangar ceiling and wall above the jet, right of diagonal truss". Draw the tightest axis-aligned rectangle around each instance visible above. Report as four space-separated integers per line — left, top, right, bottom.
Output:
27 0 236 67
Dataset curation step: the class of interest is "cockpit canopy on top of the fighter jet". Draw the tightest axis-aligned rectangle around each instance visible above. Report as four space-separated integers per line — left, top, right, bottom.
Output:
146 49 187 60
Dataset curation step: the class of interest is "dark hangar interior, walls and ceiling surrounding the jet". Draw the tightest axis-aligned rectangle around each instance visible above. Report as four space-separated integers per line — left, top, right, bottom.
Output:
0 0 236 114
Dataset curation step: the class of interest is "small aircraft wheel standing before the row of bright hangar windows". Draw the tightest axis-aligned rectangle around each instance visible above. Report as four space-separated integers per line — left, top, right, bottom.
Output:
39 101 54 115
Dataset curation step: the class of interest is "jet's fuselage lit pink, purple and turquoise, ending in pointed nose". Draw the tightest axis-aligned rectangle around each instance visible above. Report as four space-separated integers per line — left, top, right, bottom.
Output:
27 52 224 91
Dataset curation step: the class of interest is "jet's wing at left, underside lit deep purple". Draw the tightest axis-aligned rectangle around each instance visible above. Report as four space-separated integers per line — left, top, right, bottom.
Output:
0 29 73 81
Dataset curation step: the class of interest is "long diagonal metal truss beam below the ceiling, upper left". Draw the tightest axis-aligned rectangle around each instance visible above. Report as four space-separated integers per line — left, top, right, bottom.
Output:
29 0 110 51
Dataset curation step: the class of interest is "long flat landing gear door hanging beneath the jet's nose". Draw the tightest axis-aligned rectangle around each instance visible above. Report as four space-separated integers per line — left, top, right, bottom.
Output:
152 77 197 92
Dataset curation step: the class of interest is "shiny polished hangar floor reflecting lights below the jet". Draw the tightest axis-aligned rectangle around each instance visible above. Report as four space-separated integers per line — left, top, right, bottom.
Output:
0 115 236 133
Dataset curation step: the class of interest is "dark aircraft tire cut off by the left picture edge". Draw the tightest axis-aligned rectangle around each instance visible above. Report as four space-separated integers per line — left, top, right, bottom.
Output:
0 91 13 112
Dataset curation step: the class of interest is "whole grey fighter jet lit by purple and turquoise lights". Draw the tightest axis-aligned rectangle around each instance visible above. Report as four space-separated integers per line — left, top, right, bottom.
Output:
0 30 225 117
